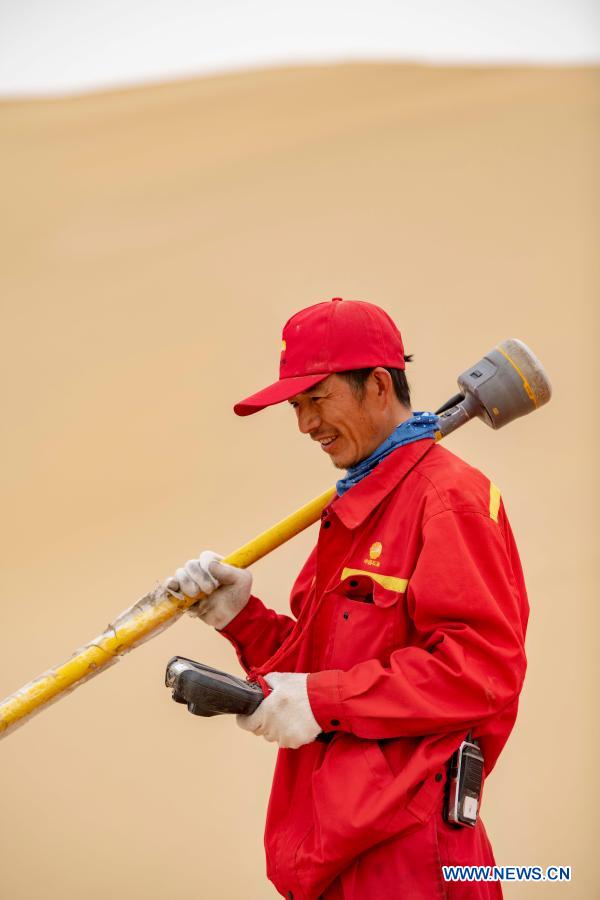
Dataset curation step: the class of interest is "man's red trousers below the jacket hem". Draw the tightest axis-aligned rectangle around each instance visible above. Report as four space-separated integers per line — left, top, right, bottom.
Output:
322 810 502 900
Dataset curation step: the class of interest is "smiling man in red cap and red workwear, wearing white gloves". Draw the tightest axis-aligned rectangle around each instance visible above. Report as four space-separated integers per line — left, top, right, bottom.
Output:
171 298 528 900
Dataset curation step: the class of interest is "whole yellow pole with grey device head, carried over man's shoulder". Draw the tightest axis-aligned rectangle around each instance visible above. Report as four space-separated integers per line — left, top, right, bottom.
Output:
0 339 551 738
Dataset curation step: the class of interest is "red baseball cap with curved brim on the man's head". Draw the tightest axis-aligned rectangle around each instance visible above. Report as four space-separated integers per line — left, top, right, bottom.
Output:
233 297 404 416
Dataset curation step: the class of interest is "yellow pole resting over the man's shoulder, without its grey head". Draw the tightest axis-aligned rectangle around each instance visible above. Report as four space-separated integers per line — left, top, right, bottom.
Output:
0 488 335 738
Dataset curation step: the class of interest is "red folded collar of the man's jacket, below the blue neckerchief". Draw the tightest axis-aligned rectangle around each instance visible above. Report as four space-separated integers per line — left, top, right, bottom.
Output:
327 438 435 528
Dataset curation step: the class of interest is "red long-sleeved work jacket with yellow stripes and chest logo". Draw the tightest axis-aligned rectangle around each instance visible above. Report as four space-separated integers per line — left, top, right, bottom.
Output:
222 439 528 900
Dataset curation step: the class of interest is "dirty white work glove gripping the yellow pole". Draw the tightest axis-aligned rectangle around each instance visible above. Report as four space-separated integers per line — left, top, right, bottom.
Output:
167 550 252 631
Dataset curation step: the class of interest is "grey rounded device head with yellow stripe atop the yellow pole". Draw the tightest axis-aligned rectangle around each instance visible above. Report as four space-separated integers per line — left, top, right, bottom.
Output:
438 338 552 437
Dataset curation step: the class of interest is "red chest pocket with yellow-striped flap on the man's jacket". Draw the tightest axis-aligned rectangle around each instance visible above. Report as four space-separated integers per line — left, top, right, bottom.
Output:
322 569 404 669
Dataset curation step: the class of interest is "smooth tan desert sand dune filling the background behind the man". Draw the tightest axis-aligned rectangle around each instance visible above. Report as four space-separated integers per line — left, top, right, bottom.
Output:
0 65 600 900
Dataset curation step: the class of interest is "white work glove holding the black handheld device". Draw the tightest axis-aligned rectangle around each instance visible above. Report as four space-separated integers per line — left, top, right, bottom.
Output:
236 672 321 750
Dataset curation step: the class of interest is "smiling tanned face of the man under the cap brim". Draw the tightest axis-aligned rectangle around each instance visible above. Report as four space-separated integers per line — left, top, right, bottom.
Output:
289 375 382 469
